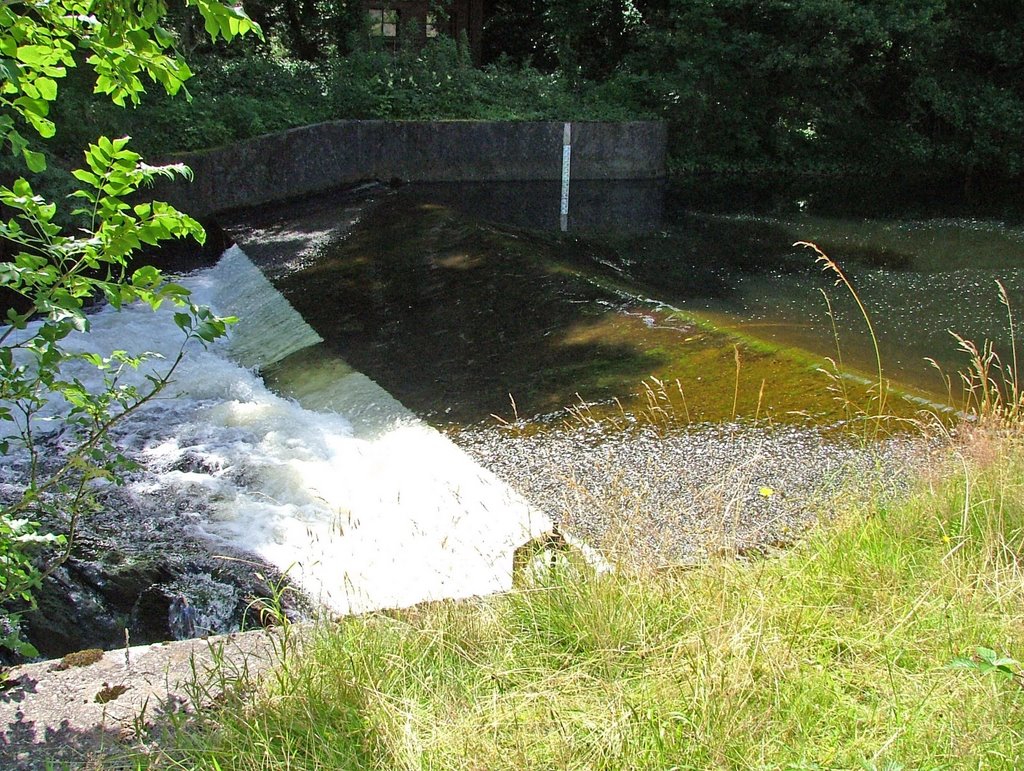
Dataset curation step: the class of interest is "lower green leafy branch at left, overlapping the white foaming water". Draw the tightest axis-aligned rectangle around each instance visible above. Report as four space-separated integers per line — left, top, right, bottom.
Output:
0 137 233 644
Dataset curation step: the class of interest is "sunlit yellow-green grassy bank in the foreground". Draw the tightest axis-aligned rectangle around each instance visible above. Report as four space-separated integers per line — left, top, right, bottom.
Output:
136 421 1024 769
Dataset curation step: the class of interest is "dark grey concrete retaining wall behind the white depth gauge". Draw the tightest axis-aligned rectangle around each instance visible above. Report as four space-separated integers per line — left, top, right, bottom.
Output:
154 121 667 217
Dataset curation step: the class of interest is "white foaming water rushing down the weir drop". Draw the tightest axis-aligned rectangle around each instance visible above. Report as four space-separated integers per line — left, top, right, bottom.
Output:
6 247 551 613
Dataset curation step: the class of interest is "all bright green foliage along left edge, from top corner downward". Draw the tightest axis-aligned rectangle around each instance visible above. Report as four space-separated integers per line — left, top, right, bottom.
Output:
0 0 254 653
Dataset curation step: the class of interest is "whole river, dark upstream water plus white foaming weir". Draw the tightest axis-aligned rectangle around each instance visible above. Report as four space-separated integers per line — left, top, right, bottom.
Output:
0 180 1024 651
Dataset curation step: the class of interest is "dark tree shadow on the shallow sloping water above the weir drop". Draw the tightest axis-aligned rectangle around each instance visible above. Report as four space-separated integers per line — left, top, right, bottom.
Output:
279 191 664 423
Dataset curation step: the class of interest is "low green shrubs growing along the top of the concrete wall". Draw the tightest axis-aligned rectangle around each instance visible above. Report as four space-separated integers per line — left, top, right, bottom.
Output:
46 39 643 161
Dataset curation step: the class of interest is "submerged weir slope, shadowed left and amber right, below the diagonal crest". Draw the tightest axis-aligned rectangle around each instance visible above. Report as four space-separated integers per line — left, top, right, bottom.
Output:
280 195 929 427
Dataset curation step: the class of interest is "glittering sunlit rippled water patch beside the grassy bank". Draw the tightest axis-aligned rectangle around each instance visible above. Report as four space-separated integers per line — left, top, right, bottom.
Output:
453 424 931 564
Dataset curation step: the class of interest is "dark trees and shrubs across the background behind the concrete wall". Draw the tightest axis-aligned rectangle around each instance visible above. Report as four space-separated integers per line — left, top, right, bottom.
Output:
18 0 1024 186
